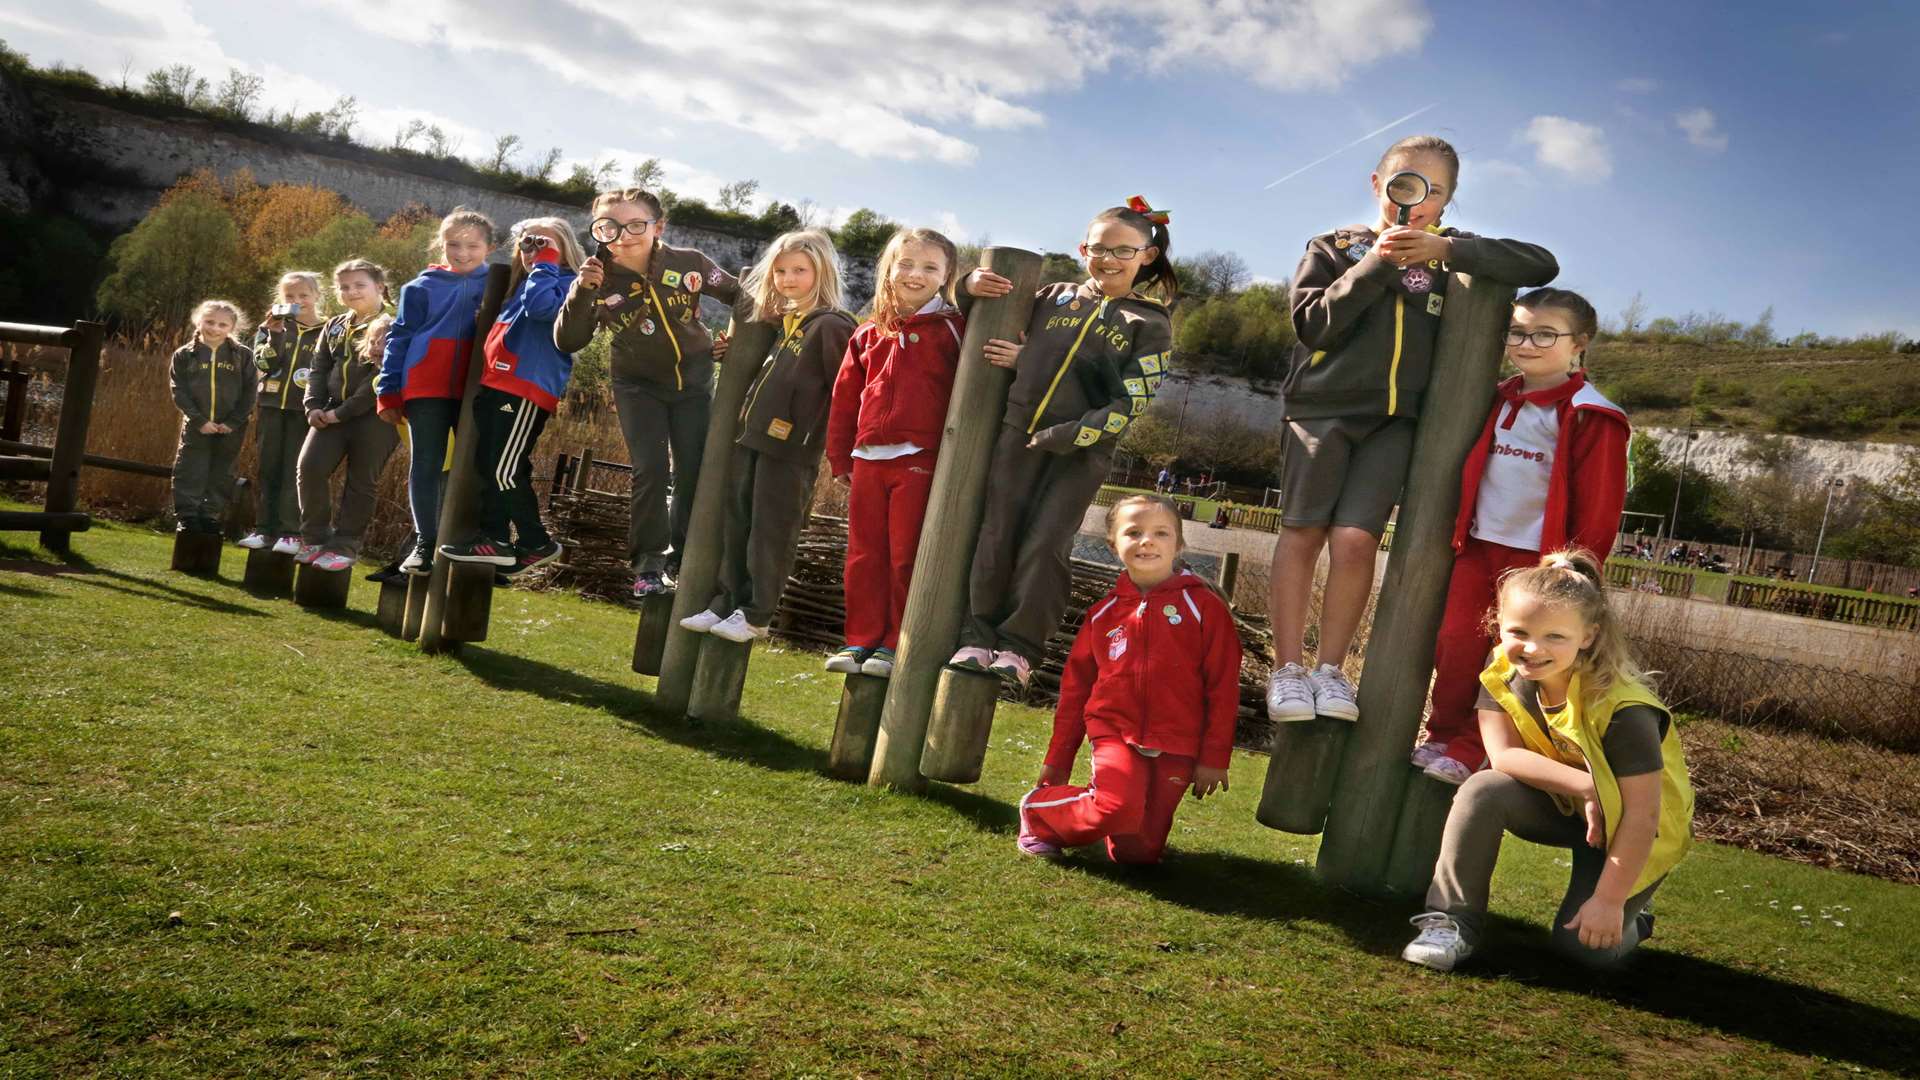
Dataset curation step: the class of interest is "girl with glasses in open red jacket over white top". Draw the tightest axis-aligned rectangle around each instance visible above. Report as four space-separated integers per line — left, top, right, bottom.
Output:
1413 288 1630 784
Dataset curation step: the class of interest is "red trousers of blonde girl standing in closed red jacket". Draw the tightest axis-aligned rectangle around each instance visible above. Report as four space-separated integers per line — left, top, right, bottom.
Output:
845 450 933 650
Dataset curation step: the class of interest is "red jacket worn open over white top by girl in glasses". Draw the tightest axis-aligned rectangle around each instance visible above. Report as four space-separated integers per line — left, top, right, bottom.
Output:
1453 371 1632 559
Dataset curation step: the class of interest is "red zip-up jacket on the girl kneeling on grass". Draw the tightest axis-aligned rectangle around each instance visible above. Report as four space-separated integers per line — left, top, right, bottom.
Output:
1046 571 1240 773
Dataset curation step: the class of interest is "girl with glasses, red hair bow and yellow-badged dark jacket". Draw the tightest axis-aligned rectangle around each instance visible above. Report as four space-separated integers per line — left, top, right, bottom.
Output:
950 196 1179 688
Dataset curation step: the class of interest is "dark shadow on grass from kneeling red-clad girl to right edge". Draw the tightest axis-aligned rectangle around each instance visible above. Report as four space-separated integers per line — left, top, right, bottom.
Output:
1066 849 1920 1074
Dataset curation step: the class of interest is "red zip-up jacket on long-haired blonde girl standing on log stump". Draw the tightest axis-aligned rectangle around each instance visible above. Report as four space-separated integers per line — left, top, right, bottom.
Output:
828 298 966 477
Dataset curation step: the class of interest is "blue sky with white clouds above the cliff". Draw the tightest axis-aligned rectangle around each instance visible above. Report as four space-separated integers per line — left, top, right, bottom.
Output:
0 0 1920 336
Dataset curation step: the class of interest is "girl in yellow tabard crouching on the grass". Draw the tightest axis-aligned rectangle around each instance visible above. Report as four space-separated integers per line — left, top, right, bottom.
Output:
1400 550 1693 970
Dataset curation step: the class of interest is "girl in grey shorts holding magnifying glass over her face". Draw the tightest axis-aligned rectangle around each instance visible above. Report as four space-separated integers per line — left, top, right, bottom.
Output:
1267 135 1559 723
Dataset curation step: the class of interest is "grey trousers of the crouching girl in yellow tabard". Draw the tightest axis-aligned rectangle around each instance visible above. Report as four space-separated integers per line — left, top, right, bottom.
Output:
1427 769 1665 967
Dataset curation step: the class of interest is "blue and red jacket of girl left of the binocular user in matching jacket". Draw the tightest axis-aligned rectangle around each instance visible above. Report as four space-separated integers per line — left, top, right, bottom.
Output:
372 263 488 411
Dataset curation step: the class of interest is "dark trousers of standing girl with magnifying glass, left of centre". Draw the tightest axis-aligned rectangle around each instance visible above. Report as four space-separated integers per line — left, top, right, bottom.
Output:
612 379 710 572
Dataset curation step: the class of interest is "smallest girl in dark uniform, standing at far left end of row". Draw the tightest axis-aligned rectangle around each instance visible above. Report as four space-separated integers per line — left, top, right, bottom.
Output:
167 300 259 534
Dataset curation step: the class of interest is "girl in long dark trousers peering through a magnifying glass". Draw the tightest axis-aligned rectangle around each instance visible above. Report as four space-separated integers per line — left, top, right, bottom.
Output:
553 188 739 596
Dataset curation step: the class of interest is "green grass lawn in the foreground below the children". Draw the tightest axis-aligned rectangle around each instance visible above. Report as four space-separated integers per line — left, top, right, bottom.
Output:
0 507 1920 1076
